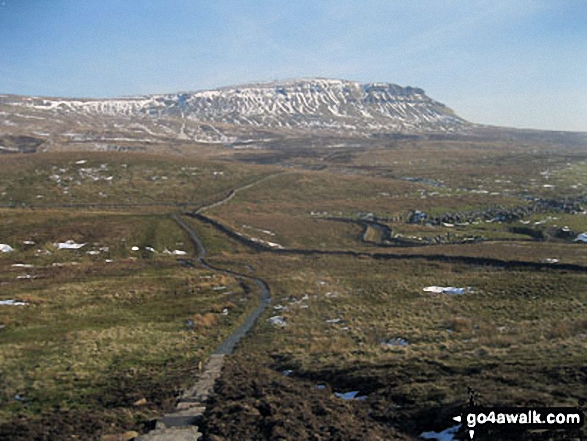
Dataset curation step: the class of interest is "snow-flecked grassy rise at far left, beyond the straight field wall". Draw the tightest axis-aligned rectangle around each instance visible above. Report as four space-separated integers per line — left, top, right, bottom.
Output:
0 152 272 205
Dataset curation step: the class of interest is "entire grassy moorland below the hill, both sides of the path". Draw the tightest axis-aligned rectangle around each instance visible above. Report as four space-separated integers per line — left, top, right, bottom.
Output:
0 136 587 440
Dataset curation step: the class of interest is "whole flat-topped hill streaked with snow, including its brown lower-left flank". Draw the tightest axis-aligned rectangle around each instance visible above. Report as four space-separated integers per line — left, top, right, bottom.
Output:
0 79 469 144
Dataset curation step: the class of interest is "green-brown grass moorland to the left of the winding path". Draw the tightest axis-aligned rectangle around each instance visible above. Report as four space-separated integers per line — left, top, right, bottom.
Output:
0 153 272 440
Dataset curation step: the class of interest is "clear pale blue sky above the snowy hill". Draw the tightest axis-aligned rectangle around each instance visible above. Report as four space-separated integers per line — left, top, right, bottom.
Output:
0 0 587 131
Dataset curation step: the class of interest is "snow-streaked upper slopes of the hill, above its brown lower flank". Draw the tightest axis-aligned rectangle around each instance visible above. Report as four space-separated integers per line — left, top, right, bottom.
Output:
3 79 467 136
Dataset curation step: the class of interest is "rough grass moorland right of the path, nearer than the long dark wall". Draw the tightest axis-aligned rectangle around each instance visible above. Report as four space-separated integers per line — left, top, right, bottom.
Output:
194 218 587 439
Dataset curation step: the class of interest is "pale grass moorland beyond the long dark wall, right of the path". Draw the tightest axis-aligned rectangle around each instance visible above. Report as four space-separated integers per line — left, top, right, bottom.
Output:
204 142 587 263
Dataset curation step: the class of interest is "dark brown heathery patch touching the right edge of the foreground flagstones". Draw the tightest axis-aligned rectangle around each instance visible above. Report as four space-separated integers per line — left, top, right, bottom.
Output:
200 356 415 441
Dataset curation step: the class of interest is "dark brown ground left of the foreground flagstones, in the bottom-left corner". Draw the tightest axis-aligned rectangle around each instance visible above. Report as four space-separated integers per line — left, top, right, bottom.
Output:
0 362 197 441
